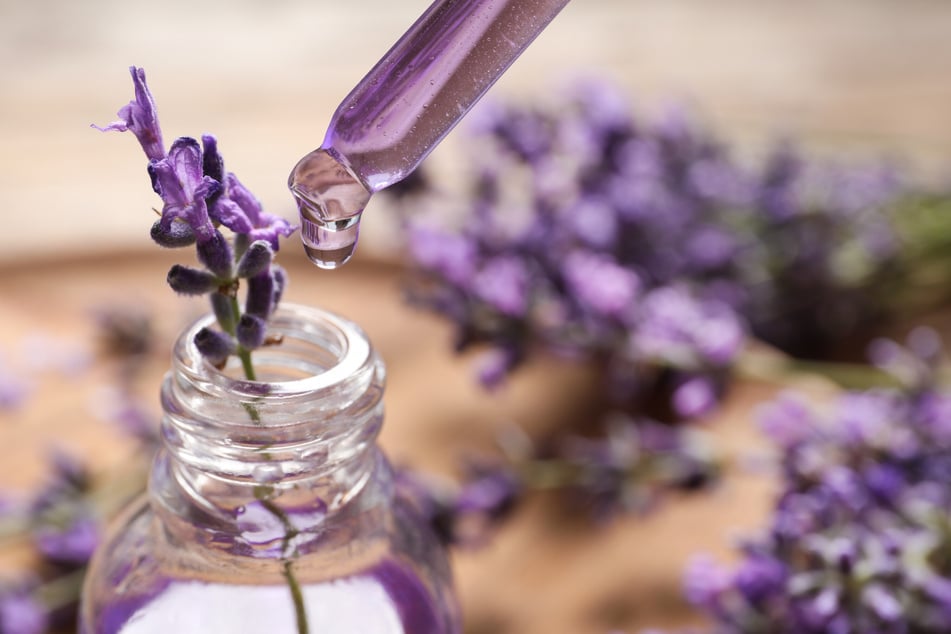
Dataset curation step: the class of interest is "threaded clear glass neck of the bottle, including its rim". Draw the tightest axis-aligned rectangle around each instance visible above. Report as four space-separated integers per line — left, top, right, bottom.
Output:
160 306 384 506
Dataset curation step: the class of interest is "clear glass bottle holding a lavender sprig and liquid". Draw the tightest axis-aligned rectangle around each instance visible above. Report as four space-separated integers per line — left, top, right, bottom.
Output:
80 306 460 634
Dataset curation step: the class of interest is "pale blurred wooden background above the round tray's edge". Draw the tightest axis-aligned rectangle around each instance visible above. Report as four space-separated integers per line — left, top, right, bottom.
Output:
0 0 951 261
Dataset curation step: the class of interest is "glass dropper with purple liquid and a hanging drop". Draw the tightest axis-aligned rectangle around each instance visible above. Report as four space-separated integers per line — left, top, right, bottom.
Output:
288 0 568 269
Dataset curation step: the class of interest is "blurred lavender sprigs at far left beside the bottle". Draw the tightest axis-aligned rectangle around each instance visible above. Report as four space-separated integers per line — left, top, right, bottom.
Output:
0 308 158 634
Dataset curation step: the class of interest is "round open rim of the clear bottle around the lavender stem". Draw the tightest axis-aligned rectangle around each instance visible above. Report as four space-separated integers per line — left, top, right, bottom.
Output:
175 304 374 399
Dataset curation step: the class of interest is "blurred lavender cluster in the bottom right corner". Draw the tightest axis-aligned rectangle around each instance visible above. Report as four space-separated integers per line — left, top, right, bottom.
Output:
686 330 951 634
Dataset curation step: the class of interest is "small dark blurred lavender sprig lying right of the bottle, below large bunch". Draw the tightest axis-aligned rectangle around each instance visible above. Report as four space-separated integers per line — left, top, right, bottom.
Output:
397 416 721 548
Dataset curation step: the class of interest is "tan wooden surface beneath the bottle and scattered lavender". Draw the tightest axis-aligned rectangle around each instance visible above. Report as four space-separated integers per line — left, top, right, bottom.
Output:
0 250 800 634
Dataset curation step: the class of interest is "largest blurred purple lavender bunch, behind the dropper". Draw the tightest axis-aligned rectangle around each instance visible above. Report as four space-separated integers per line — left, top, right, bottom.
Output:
401 76 899 418
